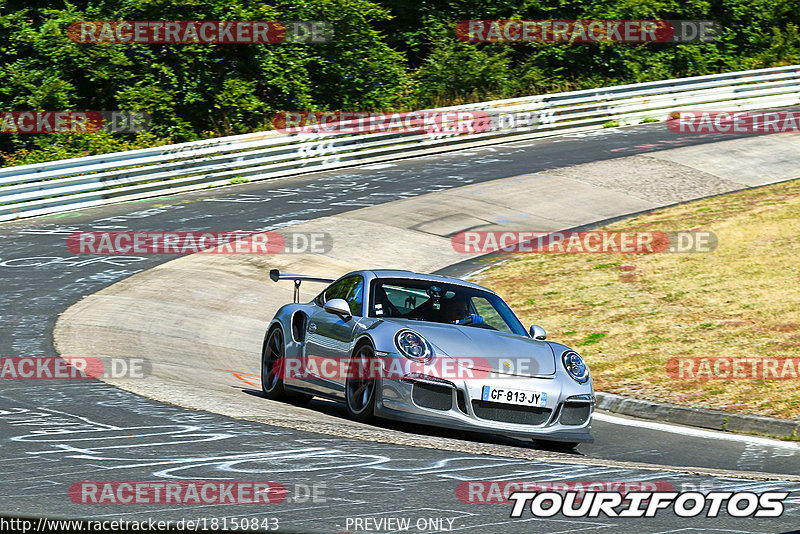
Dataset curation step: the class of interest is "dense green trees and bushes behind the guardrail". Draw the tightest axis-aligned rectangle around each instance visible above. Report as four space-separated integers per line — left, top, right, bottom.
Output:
0 0 800 165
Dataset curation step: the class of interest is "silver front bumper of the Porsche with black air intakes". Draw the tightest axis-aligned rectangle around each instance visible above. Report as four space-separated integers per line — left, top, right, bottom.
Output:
375 376 594 443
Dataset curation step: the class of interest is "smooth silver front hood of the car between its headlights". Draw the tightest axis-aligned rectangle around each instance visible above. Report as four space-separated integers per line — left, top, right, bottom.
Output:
384 319 556 377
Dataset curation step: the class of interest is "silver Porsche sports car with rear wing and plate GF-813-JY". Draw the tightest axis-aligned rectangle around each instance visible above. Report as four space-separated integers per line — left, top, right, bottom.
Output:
261 269 594 447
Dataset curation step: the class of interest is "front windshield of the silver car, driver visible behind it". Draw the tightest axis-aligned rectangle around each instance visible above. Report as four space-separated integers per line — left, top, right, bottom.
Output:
369 279 527 336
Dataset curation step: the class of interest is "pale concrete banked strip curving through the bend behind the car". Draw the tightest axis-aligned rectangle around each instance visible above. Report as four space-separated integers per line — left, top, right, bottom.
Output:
54 136 800 478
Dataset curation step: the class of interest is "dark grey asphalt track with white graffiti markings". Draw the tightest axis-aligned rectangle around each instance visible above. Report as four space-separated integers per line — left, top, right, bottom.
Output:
0 124 800 532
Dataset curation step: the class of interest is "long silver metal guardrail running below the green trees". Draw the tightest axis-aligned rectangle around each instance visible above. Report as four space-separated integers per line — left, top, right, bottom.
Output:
0 65 800 221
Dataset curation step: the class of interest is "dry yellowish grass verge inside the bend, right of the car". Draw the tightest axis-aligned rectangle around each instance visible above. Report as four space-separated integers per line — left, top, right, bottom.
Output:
475 180 800 419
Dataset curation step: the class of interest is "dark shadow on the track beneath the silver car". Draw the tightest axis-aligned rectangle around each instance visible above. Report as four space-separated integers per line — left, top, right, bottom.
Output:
241 388 584 456
